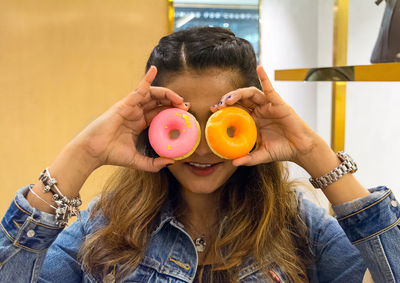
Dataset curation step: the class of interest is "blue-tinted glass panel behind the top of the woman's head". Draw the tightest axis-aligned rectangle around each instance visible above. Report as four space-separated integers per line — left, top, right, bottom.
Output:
173 0 260 60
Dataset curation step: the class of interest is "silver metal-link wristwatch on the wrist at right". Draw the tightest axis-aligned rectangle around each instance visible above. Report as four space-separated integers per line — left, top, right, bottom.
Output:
310 151 357 189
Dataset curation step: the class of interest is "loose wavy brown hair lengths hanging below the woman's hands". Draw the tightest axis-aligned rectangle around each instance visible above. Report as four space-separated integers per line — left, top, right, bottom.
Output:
80 163 307 282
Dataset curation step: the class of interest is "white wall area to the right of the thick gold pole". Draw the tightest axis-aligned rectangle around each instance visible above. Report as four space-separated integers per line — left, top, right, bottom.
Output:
346 0 400 198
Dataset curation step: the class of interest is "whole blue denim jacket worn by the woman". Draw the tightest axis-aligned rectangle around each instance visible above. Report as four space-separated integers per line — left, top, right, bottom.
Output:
0 187 400 283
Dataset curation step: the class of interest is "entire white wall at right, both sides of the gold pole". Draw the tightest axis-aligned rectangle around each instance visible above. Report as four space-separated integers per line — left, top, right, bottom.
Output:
261 0 400 201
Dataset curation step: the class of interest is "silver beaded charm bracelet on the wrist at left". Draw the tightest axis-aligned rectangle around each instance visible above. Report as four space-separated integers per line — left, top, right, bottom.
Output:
39 168 82 228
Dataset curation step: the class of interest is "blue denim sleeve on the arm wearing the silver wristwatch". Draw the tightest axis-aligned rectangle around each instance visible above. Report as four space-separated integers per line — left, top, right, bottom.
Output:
333 187 400 283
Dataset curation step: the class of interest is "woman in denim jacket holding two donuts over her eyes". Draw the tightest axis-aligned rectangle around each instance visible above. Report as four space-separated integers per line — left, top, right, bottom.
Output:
0 28 400 282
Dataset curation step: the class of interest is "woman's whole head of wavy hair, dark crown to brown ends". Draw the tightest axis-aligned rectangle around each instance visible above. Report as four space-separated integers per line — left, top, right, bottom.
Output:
79 27 309 282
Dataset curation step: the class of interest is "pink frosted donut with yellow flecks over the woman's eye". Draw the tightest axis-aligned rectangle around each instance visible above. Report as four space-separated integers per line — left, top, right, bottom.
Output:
149 108 200 160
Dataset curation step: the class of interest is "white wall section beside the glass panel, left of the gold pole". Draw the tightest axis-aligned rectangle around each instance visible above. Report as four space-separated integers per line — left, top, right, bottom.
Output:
261 0 327 207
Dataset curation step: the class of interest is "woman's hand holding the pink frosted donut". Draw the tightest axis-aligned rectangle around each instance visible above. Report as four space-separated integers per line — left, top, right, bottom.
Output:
72 66 188 172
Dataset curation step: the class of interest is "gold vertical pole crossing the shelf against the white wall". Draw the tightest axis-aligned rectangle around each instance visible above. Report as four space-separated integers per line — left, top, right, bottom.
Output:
331 0 349 152
